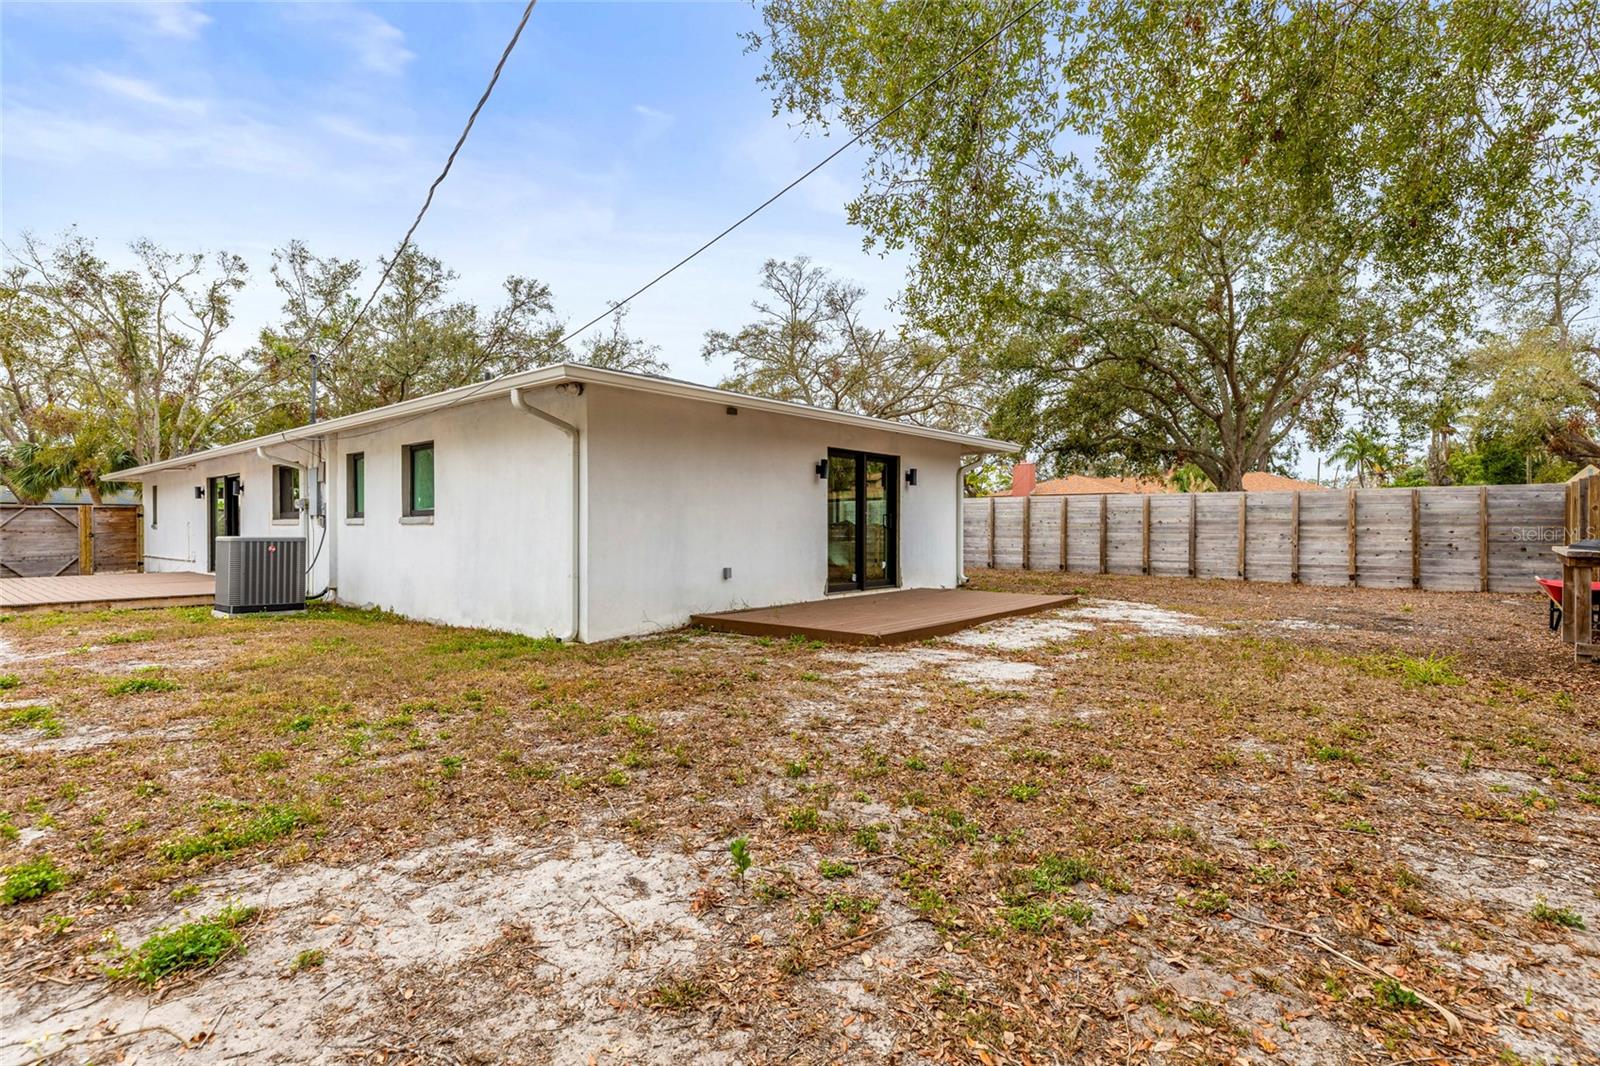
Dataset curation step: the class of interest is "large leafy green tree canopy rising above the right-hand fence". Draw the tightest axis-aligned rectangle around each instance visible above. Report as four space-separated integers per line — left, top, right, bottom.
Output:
752 0 1600 488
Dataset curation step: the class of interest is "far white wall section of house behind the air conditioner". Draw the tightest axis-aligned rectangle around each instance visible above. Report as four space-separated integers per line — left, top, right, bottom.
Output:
139 443 328 592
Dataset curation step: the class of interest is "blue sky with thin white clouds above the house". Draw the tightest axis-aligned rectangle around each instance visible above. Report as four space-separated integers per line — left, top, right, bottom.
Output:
0 0 904 381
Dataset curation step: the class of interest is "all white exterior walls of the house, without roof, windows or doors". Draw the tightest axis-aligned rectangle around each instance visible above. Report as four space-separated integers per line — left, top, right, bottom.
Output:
144 384 963 640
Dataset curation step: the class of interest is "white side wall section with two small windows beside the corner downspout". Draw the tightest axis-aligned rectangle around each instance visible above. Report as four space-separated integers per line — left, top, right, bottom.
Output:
328 389 582 637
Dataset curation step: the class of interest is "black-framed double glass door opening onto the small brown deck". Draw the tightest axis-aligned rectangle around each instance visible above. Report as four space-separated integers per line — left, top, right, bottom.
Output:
827 450 899 592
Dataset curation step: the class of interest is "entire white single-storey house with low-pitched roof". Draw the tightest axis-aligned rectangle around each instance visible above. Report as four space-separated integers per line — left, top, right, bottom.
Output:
118 363 1016 640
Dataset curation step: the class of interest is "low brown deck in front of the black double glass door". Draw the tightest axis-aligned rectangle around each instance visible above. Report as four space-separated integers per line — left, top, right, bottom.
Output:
690 589 1078 643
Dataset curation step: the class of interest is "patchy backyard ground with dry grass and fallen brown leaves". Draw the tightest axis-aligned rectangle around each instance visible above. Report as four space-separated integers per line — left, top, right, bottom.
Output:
0 571 1600 1063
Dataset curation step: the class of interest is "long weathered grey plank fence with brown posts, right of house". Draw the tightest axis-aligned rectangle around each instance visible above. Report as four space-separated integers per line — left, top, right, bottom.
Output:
962 479 1580 592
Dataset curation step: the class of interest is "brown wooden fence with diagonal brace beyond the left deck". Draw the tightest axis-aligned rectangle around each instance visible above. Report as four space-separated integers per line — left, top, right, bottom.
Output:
0 504 144 579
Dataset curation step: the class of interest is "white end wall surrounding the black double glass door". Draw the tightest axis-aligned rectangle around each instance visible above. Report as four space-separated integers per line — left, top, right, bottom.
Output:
582 386 962 640
